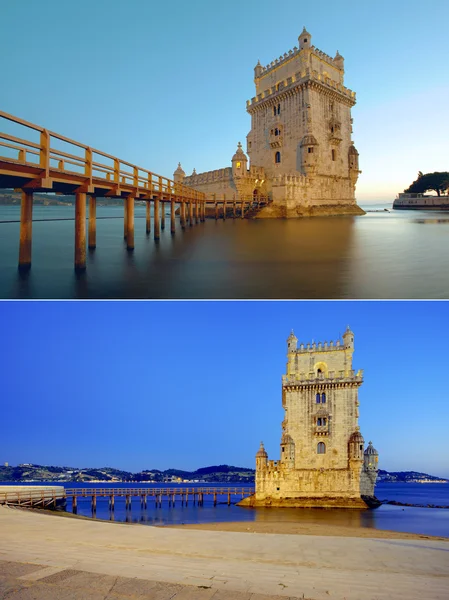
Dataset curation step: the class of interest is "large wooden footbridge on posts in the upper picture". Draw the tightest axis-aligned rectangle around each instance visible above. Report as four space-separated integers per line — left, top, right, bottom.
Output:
0 111 206 271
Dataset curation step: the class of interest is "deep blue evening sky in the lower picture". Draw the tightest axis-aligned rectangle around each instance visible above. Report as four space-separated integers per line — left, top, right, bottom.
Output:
0 301 449 477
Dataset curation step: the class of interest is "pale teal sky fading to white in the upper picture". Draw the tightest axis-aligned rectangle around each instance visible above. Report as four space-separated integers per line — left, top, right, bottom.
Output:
0 0 449 202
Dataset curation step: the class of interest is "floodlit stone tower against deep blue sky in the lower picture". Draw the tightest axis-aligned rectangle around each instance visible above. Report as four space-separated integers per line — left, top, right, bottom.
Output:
244 327 378 508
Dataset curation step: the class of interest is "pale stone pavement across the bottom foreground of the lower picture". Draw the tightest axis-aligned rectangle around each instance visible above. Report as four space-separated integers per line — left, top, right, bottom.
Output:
0 507 449 600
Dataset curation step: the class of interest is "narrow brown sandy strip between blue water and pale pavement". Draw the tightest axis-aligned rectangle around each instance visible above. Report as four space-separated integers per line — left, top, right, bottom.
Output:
167 521 449 542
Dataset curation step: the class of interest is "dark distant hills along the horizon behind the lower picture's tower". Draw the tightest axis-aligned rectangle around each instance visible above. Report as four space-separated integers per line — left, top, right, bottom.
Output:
0 464 449 484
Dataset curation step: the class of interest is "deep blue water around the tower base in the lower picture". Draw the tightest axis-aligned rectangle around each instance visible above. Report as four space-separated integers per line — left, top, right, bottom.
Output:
7 483 449 537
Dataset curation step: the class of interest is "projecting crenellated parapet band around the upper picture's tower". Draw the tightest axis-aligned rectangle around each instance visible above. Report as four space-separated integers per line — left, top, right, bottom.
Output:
246 68 356 112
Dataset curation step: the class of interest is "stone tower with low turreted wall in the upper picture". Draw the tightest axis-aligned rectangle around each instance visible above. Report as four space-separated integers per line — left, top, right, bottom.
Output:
174 28 364 217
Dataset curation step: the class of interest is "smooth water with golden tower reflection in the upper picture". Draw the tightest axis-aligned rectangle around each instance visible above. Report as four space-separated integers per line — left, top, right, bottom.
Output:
0 204 449 298
